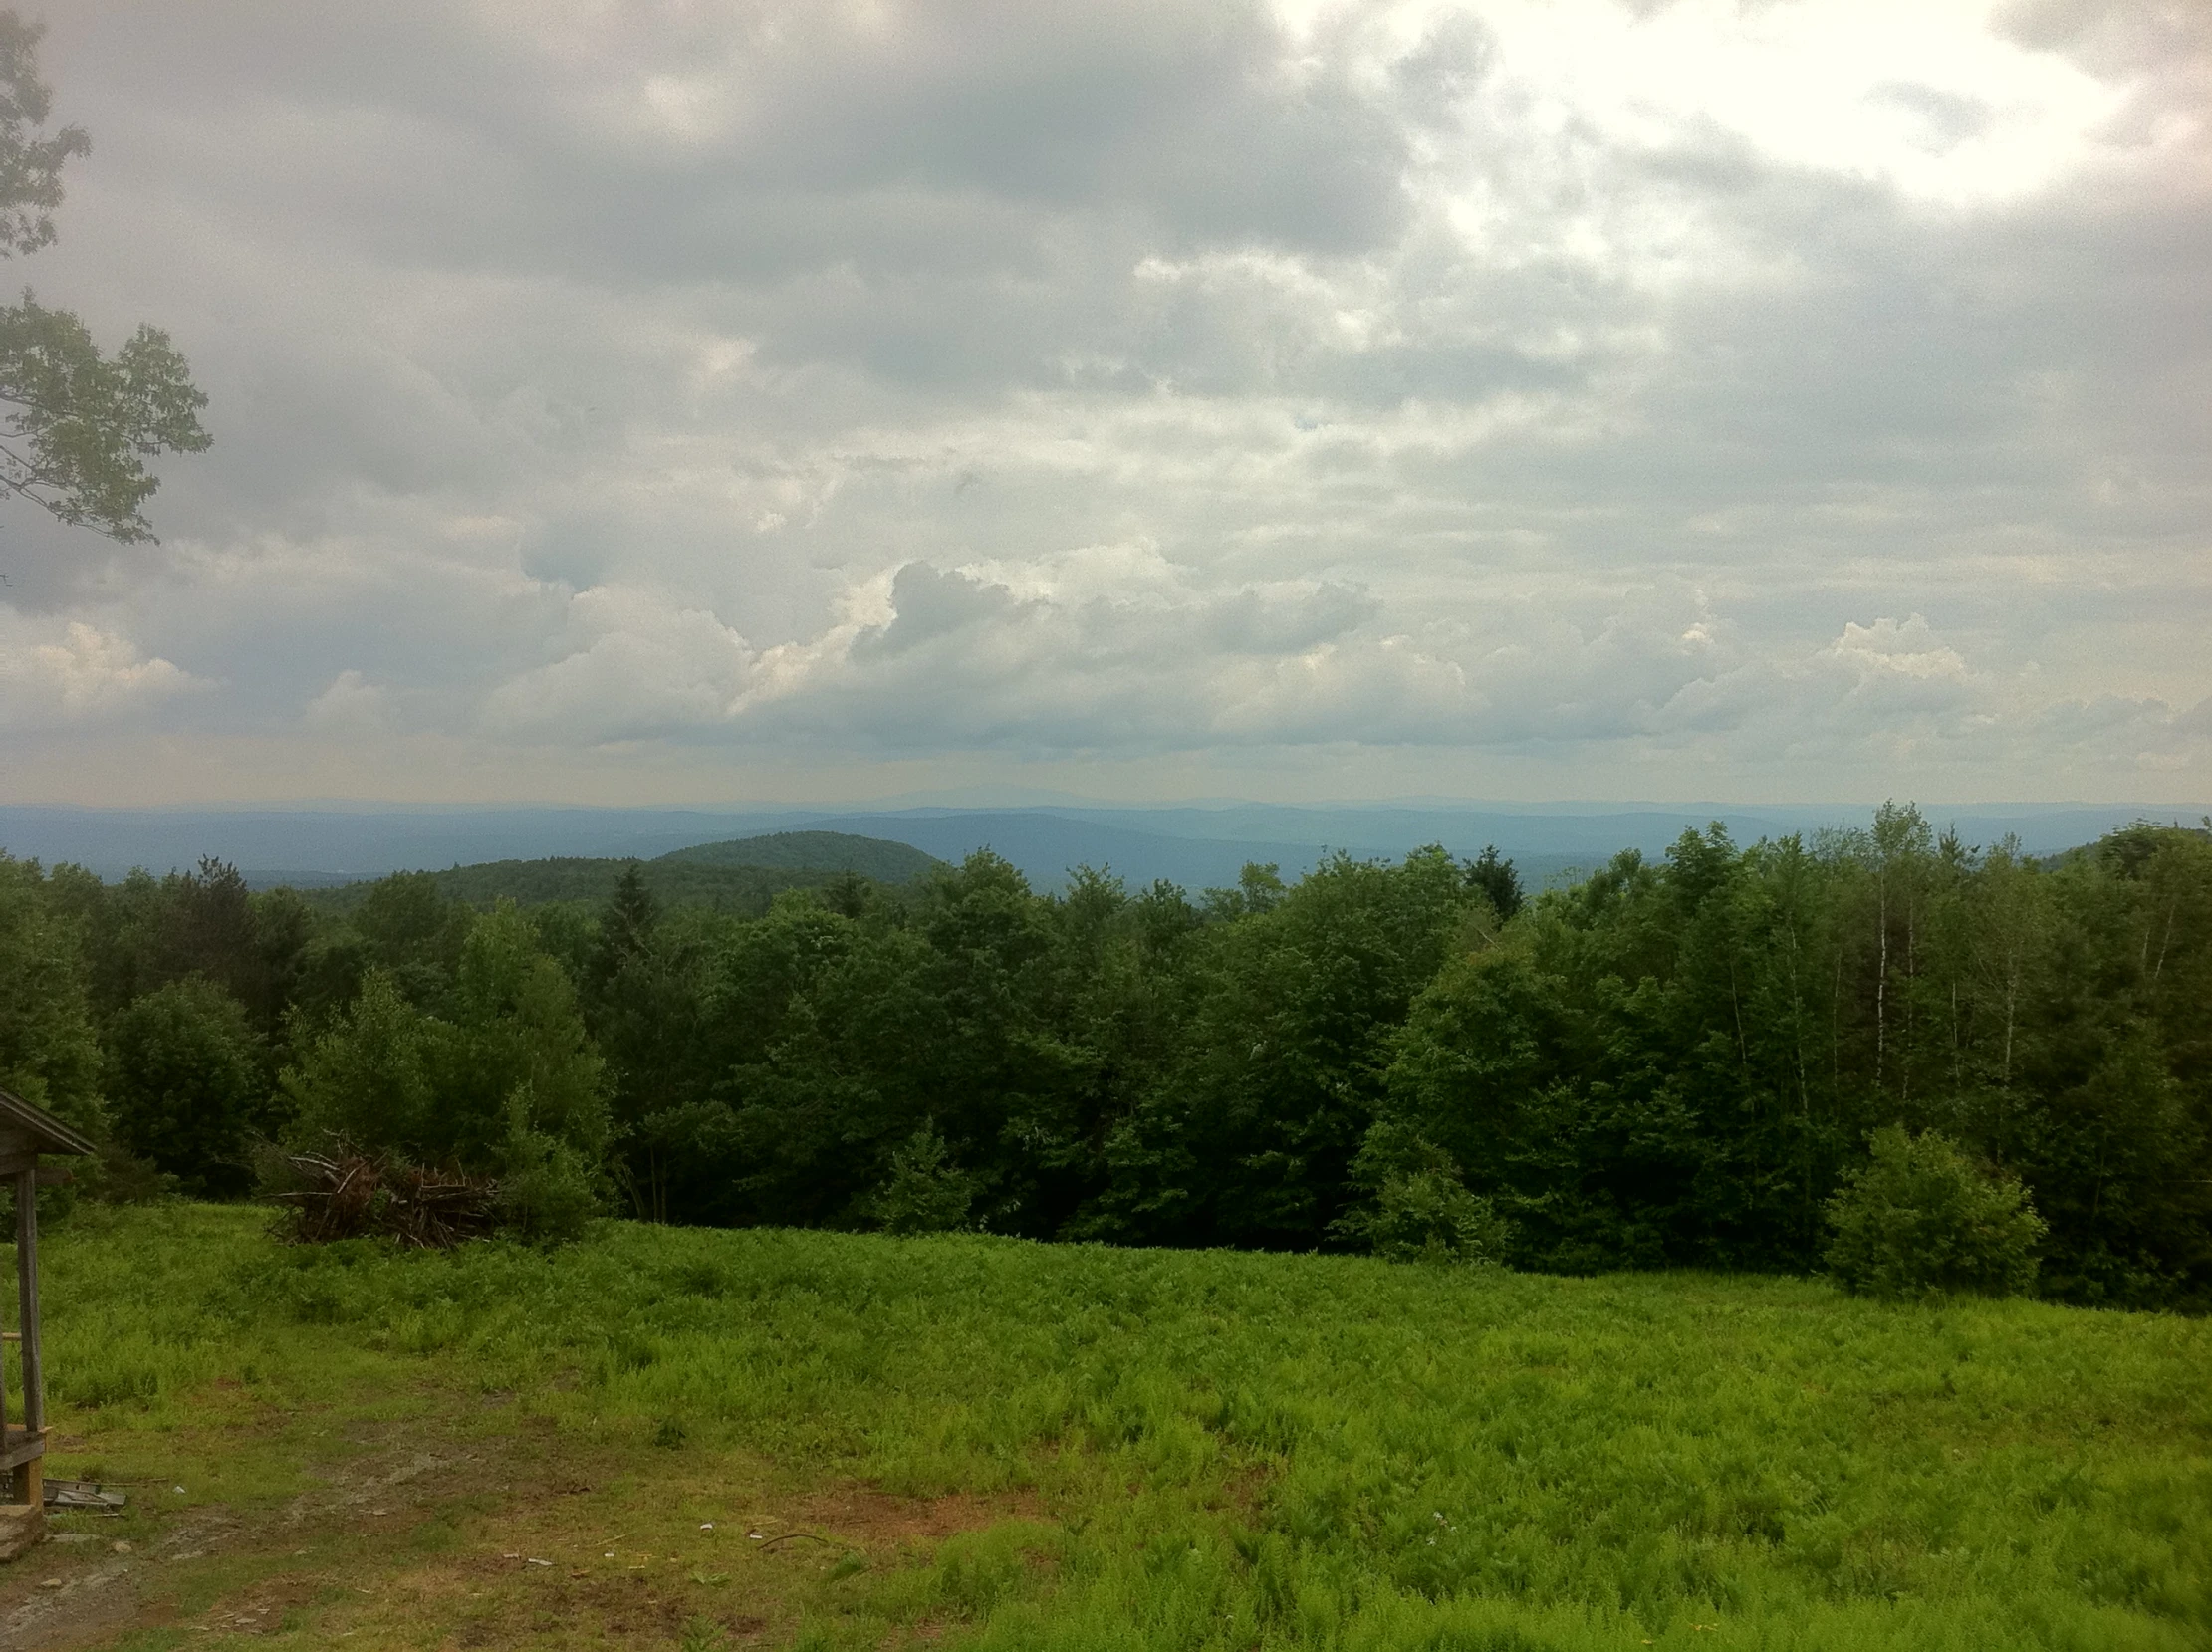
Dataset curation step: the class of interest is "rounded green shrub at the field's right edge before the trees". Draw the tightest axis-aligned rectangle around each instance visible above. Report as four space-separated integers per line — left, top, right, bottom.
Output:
1828 1125 2044 1298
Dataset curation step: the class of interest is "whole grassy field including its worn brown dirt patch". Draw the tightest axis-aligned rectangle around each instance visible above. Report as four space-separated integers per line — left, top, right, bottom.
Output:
0 1205 2212 1652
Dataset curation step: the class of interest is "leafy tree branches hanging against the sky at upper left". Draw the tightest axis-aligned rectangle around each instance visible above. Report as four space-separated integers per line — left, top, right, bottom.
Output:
0 11 210 544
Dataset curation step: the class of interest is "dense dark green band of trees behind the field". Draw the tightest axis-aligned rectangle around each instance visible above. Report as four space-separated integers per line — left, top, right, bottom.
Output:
0 805 2212 1307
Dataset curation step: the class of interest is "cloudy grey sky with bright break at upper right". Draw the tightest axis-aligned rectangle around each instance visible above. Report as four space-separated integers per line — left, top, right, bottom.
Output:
0 0 2212 805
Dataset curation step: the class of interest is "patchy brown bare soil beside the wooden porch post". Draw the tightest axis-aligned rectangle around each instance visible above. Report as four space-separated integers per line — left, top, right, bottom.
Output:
0 1395 1042 1652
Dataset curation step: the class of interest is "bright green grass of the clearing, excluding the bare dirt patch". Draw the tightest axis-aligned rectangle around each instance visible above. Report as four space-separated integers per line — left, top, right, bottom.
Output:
21 1208 2212 1652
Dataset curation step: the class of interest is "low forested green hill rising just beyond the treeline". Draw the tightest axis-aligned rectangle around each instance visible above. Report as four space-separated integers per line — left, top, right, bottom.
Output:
308 831 938 918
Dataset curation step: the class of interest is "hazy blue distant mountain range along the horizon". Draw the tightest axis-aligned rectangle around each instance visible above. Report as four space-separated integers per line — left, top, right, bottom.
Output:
0 801 2203 891
